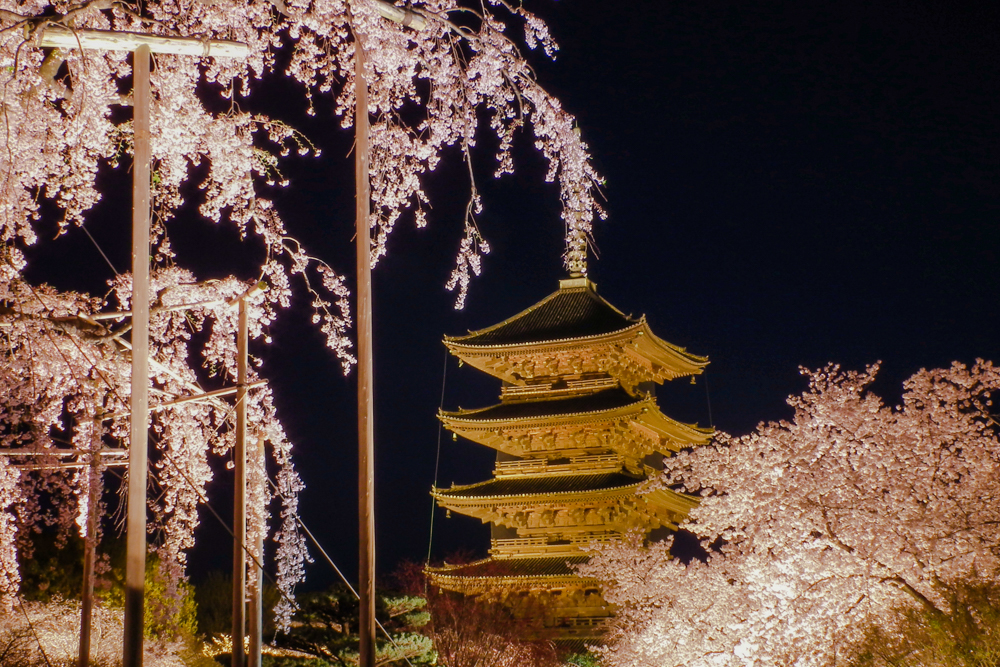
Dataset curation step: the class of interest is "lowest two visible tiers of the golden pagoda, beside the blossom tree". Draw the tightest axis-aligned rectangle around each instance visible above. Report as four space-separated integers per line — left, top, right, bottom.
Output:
427 464 697 642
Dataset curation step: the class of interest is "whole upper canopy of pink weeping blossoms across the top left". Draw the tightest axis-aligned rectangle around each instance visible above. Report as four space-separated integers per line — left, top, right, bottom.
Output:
0 0 604 312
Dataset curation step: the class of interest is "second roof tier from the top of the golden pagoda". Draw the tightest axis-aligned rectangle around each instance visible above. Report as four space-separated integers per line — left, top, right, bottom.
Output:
438 386 713 469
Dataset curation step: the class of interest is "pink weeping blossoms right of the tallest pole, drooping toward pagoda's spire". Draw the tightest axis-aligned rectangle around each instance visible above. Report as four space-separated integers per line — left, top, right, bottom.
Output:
342 2 604 298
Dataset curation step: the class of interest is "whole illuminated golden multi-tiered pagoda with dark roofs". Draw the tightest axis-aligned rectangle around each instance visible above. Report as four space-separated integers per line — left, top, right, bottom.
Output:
428 277 713 640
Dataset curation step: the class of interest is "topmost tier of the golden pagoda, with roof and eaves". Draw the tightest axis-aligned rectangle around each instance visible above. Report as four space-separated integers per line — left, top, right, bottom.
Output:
444 278 708 395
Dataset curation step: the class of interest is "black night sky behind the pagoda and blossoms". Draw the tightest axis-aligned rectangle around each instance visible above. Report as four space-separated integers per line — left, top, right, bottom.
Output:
23 0 1000 586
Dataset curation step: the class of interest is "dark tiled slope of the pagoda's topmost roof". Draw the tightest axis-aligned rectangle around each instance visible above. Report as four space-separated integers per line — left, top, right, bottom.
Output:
445 287 639 345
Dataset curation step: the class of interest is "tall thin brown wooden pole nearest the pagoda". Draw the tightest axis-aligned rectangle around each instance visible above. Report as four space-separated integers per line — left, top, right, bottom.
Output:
354 32 375 667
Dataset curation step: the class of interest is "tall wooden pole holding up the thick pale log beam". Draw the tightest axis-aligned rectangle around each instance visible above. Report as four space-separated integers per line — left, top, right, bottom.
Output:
122 45 150 667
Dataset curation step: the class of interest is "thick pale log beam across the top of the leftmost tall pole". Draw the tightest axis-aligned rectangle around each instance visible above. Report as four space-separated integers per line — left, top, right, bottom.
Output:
38 25 250 58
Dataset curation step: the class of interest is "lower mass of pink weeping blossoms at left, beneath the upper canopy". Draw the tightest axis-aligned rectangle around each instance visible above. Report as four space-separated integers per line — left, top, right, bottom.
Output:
0 267 307 618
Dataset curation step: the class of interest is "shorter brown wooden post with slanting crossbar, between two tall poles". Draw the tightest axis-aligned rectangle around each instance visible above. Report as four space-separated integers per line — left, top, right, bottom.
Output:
232 297 249 667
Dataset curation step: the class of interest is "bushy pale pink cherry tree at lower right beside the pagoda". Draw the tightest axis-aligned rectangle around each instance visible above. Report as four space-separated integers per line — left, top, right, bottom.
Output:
584 361 1000 667
